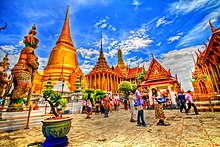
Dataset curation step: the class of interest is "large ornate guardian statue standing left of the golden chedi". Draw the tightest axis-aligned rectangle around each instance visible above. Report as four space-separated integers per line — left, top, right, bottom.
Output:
7 24 39 111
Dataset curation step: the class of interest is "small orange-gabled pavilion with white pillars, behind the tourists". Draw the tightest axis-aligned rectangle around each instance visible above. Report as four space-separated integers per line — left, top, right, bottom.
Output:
141 55 180 105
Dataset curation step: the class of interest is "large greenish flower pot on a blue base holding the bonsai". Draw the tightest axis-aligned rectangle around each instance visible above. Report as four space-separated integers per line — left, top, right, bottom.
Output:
42 118 72 147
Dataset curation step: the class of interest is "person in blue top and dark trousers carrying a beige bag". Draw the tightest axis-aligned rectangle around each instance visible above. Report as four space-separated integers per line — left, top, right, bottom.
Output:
135 85 146 126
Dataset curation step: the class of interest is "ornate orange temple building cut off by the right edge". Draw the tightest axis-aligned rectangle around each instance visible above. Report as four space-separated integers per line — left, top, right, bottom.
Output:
192 21 220 98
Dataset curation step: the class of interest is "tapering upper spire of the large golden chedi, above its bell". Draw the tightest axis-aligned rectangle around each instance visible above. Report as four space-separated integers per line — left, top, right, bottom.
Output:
56 6 74 46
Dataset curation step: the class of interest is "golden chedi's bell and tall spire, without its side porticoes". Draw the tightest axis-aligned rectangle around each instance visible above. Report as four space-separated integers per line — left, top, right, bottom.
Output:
43 6 79 89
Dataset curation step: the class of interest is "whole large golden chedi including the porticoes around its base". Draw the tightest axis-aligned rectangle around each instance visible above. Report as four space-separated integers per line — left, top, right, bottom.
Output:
34 6 87 93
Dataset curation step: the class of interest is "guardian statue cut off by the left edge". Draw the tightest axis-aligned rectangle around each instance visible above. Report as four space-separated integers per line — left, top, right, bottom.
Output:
0 54 12 106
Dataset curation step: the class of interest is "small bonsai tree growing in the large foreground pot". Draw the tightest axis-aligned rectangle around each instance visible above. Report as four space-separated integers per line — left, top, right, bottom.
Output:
43 89 67 117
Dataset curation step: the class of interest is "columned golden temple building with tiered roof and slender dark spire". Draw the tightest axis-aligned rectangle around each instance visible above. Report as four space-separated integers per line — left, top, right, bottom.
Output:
86 38 123 93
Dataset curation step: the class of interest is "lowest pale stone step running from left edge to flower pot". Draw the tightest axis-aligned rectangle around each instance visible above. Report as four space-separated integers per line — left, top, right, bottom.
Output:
0 122 42 132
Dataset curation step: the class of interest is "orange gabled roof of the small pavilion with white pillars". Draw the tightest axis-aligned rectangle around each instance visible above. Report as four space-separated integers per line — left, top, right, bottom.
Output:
141 56 178 86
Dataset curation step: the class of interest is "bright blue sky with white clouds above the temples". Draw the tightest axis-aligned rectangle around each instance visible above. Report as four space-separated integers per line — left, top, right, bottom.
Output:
0 0 220 90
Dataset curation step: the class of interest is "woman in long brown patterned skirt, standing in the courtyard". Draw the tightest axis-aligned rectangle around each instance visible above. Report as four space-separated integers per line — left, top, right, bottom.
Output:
151 88 169 126
